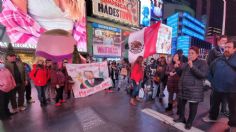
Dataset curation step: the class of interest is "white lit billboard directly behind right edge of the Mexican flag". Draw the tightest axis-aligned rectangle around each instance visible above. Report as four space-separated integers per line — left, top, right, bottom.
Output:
156 24 172 54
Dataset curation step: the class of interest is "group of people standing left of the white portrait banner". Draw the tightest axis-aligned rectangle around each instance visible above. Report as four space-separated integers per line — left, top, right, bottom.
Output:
0 51 74 120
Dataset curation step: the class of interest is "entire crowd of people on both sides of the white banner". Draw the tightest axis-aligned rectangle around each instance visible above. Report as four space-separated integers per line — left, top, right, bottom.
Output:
0 36 236 130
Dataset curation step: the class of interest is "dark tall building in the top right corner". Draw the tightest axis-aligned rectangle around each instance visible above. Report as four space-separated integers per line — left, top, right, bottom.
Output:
191 0 236 36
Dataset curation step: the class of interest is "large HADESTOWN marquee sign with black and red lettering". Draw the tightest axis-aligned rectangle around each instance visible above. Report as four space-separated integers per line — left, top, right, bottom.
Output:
92 0 139 27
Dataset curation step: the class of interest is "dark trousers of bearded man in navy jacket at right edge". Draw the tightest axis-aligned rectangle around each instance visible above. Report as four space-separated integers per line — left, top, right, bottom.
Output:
209 91 236 127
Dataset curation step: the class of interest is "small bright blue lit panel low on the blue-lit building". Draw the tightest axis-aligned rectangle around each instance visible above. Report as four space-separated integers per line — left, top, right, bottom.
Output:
177 36 190 56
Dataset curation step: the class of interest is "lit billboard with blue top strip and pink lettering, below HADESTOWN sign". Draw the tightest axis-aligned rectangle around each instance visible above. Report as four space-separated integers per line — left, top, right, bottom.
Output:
92 23 122 57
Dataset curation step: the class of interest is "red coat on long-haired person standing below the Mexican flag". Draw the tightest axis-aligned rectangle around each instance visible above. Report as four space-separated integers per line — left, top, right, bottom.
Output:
131 64 144 83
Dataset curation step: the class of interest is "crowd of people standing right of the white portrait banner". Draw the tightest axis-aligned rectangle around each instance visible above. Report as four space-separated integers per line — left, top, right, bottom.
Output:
106 36 236 131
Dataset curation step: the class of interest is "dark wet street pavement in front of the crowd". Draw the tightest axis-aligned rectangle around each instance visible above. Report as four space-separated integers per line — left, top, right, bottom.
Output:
0 89 230 132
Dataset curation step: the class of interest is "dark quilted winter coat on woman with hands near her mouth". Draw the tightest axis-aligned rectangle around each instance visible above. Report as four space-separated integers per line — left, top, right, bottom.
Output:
177 59 208 102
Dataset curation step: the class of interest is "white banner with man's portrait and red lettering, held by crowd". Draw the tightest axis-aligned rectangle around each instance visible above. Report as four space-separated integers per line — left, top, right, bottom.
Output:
66 61 113 98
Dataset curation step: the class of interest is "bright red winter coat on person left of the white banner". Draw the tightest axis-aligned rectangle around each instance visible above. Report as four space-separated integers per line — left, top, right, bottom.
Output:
30 65 49 86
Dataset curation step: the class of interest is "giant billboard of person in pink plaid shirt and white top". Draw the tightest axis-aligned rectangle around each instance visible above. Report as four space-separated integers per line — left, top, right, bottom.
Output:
0 0 87 52
